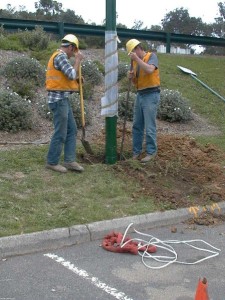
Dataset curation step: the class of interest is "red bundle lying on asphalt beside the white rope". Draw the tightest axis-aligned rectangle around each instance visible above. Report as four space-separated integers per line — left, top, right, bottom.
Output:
102 232 157 255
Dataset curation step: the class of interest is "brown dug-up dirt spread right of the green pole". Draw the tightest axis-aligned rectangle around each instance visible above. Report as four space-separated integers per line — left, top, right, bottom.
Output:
109 134 225 210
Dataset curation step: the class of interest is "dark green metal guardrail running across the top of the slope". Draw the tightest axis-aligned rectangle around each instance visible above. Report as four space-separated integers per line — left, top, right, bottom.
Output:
0 18 225 53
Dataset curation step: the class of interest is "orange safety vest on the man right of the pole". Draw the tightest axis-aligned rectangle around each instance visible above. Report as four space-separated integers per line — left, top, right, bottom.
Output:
132 52 160 91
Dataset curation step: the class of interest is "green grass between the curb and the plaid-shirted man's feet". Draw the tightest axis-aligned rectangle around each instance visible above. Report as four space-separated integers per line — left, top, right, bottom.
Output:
0 146 156 236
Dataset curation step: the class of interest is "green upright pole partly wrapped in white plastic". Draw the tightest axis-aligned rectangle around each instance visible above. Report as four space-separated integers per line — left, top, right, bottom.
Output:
101 0 118 164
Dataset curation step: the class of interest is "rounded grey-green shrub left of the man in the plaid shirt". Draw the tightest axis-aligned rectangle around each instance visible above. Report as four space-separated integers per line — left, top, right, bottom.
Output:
2 56 45 98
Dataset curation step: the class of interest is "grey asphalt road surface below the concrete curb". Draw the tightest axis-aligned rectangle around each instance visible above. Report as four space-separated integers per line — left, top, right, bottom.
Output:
0 223 225 300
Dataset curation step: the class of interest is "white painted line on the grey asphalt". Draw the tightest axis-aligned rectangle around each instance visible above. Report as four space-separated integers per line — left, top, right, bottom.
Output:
44 253 133 300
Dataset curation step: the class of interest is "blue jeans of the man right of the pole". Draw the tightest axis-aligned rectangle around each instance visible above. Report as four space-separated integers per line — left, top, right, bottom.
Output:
132 92 160 155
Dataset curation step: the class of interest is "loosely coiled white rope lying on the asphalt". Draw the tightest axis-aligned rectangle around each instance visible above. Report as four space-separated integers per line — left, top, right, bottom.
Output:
120 223 221 269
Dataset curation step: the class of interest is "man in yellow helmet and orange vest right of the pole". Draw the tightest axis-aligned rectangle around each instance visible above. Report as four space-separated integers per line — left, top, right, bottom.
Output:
126 39 160 163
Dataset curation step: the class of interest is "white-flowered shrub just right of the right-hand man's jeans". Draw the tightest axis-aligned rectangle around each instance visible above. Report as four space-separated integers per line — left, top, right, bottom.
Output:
157 89 192 122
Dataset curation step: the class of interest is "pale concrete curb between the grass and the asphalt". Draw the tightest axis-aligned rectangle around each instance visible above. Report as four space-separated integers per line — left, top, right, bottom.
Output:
0 202 225 259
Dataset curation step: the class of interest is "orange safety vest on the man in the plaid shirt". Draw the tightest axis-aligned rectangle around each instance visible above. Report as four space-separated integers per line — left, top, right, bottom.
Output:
45 51 79 92
